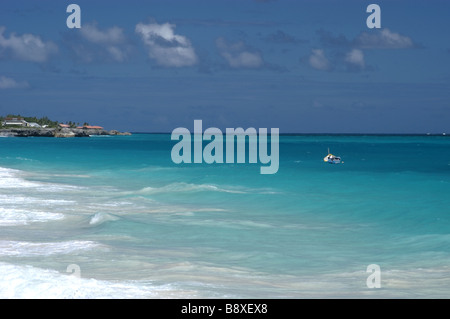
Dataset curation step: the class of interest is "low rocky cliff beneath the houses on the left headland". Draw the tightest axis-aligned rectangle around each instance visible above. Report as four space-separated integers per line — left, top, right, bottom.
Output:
0 127 131 137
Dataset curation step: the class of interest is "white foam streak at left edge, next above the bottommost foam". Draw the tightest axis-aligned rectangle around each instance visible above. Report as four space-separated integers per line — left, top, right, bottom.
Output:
0 240 105 257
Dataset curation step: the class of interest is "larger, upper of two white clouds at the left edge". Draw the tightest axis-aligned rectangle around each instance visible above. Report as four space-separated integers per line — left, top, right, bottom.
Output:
0 27 58 62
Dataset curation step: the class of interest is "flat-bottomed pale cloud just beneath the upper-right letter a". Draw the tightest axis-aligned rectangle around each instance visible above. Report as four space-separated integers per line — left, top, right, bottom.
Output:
354 29 416 49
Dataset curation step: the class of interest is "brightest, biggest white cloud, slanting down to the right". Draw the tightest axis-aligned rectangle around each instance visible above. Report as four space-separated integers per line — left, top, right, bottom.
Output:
135 23 198 67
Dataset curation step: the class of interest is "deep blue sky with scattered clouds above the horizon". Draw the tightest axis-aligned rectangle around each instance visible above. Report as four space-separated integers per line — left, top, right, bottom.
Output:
0 0 450 133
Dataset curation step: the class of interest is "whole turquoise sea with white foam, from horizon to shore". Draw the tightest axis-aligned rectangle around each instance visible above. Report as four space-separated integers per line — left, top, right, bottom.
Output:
0 134 450 298
